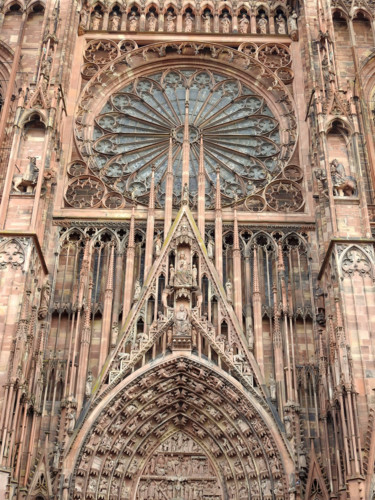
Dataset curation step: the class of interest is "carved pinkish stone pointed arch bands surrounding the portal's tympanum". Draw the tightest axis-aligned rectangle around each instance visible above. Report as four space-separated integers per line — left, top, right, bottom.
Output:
64 355 293 499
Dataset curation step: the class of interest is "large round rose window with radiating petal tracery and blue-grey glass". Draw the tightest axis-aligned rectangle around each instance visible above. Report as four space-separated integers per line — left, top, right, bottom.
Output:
89 69 285 208
